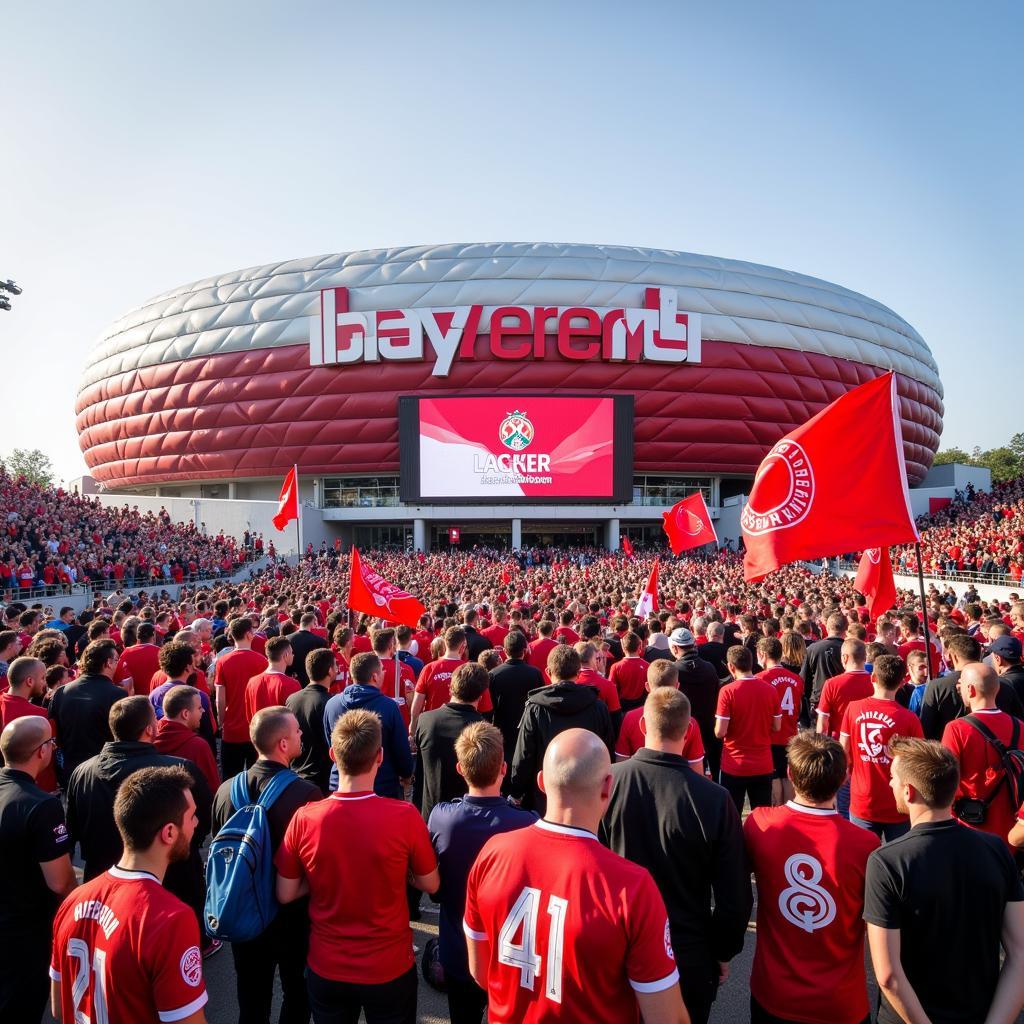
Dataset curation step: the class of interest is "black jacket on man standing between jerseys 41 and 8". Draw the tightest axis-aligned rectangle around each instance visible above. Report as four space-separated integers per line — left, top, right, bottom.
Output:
600 748 754 965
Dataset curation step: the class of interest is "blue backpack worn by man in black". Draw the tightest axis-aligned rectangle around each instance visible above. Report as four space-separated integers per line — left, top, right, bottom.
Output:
203 768 298 942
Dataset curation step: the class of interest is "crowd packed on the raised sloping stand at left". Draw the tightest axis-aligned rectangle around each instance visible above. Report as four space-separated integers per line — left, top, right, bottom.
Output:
0 468 263 601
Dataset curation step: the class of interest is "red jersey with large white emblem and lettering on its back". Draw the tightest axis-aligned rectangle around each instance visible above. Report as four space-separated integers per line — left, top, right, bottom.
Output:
840 696 925 831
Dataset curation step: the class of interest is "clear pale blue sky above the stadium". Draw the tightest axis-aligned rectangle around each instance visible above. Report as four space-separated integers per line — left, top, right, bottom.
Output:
0 0 1024 477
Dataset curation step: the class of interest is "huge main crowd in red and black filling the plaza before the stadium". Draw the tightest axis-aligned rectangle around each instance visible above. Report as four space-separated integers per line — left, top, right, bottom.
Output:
0 548 1024 1024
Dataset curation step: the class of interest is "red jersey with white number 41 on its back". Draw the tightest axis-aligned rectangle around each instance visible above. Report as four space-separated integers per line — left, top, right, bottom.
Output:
463 821 679 1024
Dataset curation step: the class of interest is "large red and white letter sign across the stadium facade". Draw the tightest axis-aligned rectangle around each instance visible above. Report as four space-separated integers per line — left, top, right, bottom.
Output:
309 288 700 377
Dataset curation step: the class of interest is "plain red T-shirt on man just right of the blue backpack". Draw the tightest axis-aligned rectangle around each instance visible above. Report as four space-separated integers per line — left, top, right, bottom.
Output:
274 793 437 985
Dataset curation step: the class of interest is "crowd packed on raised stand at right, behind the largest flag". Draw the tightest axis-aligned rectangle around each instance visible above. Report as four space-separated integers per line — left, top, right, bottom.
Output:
892 477 1024 586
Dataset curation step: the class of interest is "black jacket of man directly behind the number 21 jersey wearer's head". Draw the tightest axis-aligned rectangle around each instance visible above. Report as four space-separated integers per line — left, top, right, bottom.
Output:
68 740 212 882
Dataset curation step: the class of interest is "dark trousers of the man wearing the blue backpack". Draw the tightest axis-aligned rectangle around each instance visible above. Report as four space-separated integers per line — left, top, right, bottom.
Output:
231 900 309 1024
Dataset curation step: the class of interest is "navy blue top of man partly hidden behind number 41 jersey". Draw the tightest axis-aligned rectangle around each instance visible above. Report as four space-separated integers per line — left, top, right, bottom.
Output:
427 797 537 981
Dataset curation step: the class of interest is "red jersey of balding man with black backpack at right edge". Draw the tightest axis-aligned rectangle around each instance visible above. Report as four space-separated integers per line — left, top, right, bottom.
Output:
942 708 1024 845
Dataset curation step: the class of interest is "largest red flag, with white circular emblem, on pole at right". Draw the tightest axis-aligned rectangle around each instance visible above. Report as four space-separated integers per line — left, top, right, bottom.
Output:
739 373 920 582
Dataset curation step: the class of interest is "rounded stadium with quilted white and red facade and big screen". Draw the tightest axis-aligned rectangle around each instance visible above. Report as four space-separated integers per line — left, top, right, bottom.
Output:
76 243 943 550
